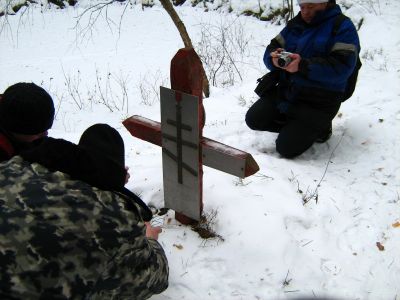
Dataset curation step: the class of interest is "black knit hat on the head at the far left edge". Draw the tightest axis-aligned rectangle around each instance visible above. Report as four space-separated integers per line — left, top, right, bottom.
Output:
0 82 54 135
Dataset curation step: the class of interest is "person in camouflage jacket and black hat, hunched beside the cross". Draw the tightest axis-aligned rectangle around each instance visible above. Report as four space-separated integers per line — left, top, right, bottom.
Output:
0 124 168 300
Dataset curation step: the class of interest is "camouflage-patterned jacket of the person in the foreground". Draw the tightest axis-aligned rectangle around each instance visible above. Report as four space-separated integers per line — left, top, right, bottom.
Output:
0 156 168 299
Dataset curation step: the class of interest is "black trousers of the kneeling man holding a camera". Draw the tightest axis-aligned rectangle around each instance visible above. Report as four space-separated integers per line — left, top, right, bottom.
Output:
246 91 340 158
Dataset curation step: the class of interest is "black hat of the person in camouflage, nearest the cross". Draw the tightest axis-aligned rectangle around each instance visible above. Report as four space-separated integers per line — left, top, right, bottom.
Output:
78 124 126 188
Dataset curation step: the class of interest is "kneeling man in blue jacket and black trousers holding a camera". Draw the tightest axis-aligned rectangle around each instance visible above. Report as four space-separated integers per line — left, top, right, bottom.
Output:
246 0 360 158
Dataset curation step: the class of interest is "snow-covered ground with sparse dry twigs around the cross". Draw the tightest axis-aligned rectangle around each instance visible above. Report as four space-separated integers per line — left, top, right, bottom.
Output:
0 0 400 300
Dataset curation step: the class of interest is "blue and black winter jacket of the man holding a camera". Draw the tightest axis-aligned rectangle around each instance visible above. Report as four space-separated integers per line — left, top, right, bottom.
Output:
264 5 360 102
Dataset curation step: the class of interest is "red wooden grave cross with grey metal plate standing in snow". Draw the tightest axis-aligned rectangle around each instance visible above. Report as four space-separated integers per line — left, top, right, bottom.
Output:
123 48 259 224
